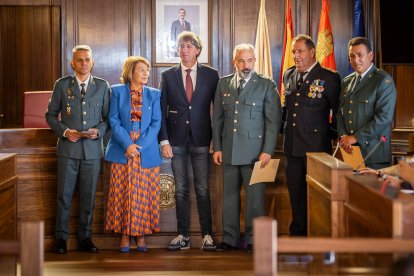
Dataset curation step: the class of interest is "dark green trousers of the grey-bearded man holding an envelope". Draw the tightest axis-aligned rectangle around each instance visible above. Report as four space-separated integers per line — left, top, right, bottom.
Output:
222 164 266 247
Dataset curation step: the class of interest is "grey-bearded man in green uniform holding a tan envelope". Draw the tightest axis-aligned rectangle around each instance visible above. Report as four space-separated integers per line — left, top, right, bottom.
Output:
213 44 282 251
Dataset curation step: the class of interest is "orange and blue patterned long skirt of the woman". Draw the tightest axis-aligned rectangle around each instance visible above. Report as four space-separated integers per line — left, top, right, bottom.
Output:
105 131 160 236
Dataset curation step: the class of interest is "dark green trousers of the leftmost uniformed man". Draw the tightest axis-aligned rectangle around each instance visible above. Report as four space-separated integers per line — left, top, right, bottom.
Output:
55 157 101 240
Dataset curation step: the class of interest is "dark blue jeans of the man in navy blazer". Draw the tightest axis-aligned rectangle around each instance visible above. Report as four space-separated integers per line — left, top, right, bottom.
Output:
171 145 212 236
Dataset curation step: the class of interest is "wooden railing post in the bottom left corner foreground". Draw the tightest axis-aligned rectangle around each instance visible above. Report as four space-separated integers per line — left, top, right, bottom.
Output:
0 221 44 276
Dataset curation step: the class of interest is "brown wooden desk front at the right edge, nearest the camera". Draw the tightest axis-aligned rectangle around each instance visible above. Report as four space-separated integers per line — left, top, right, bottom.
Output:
344 175 414 239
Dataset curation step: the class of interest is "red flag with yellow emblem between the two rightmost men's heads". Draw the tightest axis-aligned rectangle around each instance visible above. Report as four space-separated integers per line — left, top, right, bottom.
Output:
316 0 336 70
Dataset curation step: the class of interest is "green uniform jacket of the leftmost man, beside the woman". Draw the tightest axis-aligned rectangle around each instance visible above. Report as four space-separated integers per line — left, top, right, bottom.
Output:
46 75 110 160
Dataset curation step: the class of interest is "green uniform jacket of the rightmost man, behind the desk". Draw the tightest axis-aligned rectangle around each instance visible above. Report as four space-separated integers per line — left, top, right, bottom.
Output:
336 65 397 164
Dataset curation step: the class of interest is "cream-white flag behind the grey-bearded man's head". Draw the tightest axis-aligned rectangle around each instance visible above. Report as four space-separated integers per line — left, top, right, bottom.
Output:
254 0 273 79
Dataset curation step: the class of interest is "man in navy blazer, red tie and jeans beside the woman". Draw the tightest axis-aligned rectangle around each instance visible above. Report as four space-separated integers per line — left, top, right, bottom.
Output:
158 32 219 250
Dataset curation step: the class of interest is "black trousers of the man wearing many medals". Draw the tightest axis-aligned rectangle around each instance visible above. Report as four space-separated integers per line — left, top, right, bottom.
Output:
286 156 307 236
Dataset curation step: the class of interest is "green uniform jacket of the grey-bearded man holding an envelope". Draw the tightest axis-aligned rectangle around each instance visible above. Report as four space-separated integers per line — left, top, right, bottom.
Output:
213 73 282 165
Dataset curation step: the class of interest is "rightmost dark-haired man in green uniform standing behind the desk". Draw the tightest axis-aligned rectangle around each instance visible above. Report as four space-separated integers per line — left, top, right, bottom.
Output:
336 37 397 169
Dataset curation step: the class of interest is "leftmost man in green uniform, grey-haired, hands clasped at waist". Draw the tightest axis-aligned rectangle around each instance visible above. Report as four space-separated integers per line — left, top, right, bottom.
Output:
46 45 110 254
